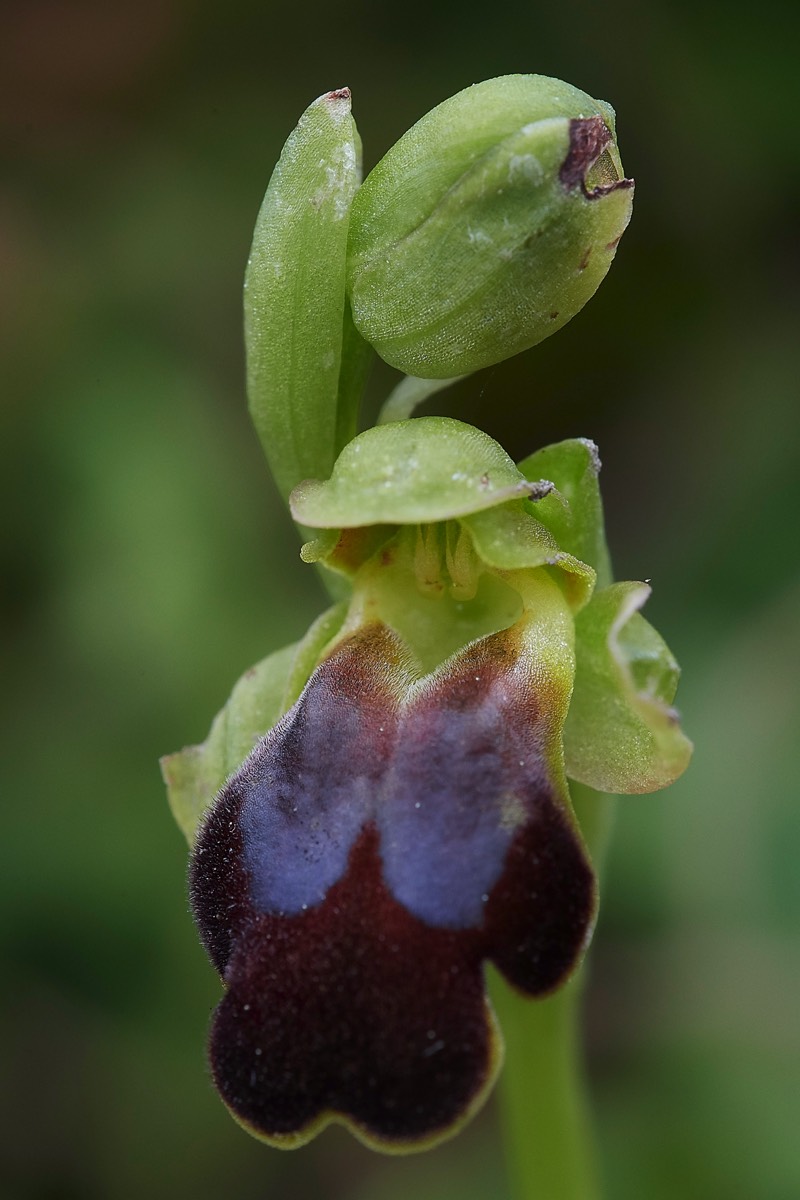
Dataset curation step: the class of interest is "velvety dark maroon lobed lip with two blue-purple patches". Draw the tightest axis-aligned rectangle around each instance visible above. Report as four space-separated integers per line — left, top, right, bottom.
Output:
191 623 595 1148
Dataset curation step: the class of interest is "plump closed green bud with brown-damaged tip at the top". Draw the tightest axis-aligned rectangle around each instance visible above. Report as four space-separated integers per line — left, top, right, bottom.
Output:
348 76 633 379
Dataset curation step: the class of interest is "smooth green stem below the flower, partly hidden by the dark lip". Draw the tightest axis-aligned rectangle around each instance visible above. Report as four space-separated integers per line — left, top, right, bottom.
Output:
492 785 614 1200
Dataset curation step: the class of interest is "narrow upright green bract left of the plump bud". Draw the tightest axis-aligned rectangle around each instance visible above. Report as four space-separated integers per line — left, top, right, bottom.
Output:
245 88 372 511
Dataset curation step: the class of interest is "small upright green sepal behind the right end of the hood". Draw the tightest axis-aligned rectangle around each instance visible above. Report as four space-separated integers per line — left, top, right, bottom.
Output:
519 438 612 587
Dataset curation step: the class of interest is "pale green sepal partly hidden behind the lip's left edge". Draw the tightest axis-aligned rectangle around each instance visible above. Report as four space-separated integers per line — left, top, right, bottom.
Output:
161 604 347 846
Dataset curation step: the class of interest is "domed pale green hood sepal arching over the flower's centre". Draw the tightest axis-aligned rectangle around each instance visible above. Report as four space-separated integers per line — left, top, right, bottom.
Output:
290 416 536 529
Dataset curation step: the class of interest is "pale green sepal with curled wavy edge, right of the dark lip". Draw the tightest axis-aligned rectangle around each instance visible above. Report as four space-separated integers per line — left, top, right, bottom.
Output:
564 582 692 792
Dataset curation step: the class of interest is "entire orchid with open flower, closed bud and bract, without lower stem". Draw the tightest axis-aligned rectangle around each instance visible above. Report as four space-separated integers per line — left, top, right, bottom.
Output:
163 76 691 1171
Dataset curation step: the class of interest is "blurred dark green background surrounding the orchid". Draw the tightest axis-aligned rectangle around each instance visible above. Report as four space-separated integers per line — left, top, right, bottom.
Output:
0 0 800 1200
